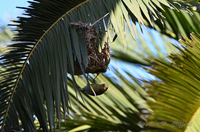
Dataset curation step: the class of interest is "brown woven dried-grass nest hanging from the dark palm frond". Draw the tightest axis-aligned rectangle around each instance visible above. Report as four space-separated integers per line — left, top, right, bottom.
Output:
67 22 110 75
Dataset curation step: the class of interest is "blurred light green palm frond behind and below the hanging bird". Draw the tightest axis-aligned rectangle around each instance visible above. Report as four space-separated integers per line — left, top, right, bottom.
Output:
54 70 153 131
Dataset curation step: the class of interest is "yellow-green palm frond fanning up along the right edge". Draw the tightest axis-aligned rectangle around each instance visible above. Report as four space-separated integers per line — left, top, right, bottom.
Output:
146 34 200 132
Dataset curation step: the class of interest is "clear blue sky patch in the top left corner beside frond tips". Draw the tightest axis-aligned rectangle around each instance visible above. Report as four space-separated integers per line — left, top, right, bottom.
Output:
0 0 31 24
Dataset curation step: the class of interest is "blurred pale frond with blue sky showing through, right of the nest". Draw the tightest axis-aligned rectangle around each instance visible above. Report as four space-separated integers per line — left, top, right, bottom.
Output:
111 24 179 66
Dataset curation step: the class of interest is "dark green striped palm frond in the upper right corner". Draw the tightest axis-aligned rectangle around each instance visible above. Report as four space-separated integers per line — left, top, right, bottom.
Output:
152 4 200 40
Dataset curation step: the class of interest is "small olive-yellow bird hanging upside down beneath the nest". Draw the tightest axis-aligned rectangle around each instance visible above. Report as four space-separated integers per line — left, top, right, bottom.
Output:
80 83 108 96
